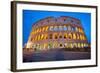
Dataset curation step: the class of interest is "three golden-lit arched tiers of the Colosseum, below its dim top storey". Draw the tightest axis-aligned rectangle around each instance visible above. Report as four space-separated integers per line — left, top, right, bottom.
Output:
26 16 88 51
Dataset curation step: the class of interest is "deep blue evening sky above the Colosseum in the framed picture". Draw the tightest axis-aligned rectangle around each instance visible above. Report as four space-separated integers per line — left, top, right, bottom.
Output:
23 10 91 45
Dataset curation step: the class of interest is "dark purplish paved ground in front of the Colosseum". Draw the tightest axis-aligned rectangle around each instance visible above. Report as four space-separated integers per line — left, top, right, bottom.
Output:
23 50 90 62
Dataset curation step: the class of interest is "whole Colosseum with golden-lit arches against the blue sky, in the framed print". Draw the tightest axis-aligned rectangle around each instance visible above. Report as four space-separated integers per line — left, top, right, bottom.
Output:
25 16 90 51
